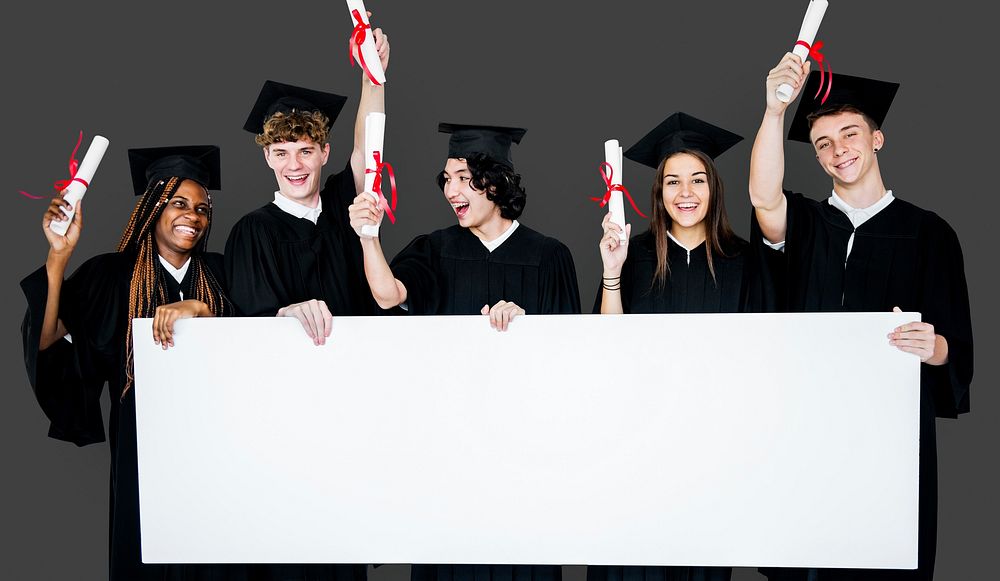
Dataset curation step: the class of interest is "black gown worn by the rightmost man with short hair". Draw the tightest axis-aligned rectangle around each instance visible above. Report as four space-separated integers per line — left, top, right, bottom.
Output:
751 192 973 581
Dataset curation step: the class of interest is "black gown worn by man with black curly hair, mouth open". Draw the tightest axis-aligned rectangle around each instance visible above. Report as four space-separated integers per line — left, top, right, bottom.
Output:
391 224 580 581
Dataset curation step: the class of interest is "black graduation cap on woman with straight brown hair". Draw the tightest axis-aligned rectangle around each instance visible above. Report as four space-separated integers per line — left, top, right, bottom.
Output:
625 112 743 169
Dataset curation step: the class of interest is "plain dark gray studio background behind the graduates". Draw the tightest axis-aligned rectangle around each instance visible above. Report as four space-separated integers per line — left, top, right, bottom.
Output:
0 0 1000 581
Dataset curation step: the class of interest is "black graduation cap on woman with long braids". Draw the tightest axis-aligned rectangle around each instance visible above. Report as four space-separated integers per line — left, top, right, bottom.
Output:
128 145 222 196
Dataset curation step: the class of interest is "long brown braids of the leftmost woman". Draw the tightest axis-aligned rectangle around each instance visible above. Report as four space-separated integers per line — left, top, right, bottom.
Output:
117 177 233 397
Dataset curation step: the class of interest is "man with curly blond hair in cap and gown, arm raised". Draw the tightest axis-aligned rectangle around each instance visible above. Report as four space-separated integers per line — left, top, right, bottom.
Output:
226 29 389 345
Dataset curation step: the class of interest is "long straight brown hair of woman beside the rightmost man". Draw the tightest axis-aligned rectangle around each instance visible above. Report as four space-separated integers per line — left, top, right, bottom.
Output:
649 149 736 288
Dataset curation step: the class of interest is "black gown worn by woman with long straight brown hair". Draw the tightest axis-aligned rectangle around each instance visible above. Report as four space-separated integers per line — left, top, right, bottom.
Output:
594 230 748 314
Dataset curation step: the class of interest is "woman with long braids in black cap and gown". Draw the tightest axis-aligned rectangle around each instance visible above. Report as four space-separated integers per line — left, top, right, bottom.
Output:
21 146 246 580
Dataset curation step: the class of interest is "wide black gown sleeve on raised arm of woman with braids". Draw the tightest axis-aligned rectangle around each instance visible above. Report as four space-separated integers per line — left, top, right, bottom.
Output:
21 255 127 446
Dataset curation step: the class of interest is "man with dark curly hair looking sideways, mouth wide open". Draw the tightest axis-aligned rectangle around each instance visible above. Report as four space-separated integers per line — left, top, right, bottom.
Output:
350 123 580 331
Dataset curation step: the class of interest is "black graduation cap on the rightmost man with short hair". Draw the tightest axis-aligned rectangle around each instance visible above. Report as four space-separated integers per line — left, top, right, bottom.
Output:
788 71 899 143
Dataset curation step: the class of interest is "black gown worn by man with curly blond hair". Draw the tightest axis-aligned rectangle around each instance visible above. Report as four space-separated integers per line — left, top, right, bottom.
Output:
226 164 375 317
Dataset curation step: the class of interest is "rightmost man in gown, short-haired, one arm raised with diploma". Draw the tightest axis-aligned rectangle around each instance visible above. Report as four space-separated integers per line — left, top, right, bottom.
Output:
750 53 973 581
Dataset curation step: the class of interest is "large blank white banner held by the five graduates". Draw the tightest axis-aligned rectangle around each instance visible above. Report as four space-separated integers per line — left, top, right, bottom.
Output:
134 313 920 568
